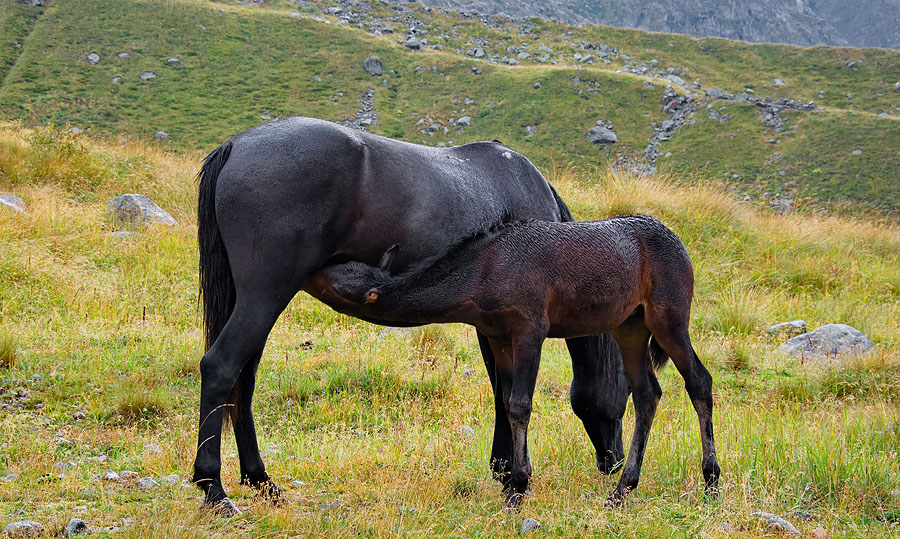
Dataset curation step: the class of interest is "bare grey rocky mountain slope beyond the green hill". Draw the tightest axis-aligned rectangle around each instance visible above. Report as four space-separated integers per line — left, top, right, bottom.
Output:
422 0 900 49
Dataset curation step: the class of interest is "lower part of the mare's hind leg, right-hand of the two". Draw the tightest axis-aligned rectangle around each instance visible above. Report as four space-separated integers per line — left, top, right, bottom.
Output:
234 354 284 504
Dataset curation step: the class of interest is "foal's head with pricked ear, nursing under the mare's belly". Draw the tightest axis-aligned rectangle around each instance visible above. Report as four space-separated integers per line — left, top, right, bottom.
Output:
311 245 399 306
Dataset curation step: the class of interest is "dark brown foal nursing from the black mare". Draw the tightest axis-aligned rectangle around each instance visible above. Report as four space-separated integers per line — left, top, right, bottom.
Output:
306 216 719 507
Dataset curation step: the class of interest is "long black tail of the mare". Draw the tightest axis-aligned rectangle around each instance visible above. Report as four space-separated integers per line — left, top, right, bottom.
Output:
197 140 235 350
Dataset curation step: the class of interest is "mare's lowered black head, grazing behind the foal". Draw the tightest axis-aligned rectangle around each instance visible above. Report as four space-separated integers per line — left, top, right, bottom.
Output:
566 333 631 474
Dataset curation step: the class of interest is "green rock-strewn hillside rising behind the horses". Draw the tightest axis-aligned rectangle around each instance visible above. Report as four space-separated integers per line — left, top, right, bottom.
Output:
0 0 900 212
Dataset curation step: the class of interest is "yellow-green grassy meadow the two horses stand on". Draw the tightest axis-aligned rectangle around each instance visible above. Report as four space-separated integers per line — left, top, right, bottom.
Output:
0 125 900 538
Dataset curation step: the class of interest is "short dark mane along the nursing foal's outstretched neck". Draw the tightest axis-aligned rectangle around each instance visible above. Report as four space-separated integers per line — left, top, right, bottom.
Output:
376 210 533 289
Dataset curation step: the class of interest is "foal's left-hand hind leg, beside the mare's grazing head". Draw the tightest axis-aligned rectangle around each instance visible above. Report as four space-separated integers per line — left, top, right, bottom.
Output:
605 317 662 506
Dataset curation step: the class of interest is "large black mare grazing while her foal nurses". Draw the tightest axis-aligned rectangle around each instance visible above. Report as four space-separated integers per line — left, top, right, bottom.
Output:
194 118 629 515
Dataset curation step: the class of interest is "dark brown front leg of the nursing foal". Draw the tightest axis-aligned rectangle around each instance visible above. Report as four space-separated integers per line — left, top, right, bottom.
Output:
491 331 546 510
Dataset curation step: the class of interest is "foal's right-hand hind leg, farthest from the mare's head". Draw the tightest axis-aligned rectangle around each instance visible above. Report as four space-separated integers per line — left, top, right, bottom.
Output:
647 311 720 497
